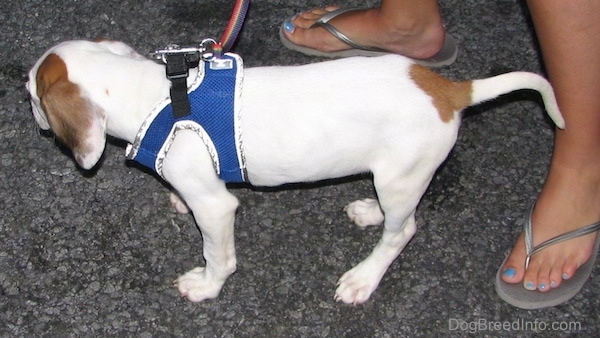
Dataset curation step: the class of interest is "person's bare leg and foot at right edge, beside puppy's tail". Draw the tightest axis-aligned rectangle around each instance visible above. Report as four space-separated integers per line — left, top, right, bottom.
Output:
502 0 600 306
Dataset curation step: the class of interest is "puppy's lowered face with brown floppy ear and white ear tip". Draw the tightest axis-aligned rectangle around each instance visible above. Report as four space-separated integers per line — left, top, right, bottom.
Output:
26 45 106 169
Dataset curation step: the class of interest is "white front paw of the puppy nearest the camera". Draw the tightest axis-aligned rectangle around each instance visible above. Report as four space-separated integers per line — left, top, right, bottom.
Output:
173 267 223 302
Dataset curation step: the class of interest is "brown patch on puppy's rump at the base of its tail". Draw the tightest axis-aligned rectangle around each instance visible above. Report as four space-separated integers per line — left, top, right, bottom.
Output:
410 64 472 122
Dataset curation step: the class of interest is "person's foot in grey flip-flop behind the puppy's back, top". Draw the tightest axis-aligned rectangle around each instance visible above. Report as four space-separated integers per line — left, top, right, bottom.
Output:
280 6 456 66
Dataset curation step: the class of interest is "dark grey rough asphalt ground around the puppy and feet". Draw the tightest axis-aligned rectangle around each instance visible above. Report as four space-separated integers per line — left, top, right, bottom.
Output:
0 0 600 337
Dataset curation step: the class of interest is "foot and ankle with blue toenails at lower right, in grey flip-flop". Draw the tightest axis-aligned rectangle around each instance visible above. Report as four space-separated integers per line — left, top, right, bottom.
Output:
501 166 600 306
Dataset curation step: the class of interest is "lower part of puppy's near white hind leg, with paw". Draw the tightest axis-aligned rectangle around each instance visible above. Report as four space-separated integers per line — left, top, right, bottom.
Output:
335 171 433 305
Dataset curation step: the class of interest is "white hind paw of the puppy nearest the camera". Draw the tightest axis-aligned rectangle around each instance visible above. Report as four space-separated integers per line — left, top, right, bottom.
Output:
334 263 381 306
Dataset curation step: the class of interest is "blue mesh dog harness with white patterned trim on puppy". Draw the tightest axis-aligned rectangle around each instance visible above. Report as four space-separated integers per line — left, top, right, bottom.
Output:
127 53 247 183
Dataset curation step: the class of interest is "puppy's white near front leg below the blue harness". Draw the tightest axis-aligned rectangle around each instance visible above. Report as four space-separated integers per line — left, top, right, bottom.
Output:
163 131 238 302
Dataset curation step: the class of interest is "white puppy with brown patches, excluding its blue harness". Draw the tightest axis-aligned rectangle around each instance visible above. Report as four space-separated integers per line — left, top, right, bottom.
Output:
27 41 564 304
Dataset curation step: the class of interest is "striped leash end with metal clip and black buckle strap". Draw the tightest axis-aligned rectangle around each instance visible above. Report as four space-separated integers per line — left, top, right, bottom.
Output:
150 0 250 118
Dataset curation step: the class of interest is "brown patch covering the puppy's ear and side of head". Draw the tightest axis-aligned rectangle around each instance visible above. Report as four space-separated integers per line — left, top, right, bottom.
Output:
36 54 93 153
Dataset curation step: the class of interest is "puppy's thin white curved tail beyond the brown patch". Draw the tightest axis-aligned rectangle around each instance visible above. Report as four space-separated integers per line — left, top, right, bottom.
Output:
471 72 565 129
